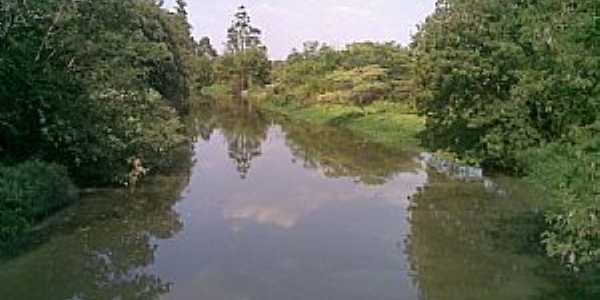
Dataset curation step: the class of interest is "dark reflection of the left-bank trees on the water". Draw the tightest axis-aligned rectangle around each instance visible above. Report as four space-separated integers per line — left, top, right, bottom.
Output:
0 151 191 300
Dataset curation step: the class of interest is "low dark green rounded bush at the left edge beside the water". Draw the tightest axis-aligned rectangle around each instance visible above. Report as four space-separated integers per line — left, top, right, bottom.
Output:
0 161 77 244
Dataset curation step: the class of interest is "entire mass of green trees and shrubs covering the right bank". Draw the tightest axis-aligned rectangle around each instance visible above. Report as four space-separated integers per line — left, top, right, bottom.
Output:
412 0 600 268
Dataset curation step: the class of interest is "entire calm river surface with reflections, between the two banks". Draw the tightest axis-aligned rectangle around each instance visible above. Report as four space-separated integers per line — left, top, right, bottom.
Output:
0 106 592 300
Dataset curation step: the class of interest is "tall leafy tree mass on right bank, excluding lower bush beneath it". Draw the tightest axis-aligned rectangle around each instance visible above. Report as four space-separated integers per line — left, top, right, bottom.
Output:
412 0 600 172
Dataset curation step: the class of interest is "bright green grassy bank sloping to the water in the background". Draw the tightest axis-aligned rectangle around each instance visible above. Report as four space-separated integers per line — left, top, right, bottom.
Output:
259 101 425 151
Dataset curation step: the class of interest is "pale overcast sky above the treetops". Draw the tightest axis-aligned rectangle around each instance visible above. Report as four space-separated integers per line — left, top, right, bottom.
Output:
165 0 435 59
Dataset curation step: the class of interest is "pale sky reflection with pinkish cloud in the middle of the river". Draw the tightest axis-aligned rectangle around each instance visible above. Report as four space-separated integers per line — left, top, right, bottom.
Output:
154 125 427 300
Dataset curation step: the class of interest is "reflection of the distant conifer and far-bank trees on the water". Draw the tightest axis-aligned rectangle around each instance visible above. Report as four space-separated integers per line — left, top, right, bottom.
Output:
203 108 418 185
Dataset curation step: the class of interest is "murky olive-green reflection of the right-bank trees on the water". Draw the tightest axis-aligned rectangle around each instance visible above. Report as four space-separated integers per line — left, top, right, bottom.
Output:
406 175 572 300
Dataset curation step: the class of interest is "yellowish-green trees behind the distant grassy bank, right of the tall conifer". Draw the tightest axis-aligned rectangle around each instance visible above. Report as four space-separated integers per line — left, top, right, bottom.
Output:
274 42 412 107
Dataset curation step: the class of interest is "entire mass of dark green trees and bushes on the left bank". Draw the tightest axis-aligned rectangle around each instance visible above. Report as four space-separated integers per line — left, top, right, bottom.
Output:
0 0 214 240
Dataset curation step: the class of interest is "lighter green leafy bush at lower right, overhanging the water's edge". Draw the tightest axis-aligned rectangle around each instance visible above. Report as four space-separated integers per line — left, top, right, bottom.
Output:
525 123 600 270
